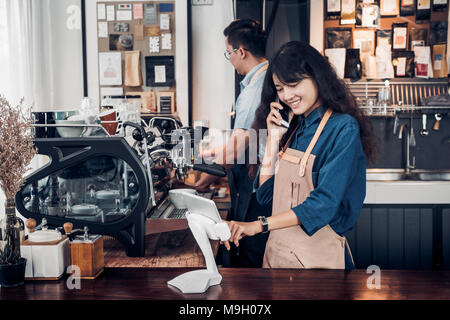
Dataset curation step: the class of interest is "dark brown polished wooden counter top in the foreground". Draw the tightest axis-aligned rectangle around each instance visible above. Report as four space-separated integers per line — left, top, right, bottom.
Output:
0 268 450 300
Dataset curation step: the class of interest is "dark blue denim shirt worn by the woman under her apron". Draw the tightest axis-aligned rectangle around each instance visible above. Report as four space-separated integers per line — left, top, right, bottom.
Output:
254 106 366 268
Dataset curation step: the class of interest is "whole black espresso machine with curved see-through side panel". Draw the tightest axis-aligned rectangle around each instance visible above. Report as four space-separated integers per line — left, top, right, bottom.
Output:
15 117 226 257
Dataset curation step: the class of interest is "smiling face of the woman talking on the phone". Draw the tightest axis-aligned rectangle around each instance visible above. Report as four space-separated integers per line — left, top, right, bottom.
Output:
272 74 321 117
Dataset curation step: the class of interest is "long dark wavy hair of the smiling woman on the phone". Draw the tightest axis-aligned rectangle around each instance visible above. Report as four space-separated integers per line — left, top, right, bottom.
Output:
249 41 377 177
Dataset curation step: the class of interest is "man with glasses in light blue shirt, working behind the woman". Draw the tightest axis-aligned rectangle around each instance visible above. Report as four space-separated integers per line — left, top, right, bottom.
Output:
190 19 271 267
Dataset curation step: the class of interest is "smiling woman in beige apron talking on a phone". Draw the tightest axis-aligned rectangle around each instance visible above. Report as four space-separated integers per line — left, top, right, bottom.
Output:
225 42 375 269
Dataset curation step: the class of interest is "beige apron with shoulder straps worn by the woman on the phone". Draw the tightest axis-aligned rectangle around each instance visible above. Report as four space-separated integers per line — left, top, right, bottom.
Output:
263 109 353 269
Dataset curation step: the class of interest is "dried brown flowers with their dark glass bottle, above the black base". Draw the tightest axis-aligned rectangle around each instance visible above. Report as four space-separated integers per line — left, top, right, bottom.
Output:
0 95 37 264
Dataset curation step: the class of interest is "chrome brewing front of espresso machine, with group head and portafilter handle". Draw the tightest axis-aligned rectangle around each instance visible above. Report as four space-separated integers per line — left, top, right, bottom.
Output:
133 117 227 222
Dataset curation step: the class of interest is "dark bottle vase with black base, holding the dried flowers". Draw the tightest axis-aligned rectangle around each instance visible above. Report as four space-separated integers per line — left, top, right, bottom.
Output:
0 199 26 287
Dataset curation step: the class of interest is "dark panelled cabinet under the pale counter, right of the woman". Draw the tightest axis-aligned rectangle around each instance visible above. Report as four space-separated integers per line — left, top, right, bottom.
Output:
346 204 450 270
